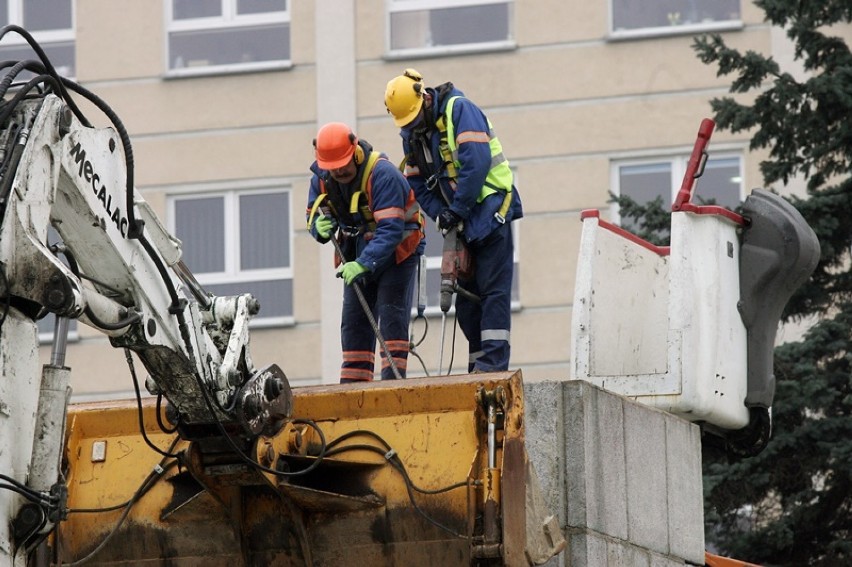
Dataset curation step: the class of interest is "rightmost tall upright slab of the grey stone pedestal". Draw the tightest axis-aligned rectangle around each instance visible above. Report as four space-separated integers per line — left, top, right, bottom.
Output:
666 415 704 565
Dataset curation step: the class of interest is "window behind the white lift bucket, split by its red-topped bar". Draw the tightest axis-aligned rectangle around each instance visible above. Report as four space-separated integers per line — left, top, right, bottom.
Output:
612 154 743 229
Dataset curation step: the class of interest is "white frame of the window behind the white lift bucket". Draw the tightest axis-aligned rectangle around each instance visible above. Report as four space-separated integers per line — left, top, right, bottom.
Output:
609 151 745 225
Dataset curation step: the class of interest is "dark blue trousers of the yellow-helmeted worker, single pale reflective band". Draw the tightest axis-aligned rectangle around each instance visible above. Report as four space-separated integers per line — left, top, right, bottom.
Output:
456 222 515 372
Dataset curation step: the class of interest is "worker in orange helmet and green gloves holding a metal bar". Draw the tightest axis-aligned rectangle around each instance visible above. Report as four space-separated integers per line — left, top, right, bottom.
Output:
306 122 425 383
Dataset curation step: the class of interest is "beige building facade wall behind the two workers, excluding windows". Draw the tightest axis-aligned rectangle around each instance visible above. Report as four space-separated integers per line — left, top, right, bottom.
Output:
35 0 804 396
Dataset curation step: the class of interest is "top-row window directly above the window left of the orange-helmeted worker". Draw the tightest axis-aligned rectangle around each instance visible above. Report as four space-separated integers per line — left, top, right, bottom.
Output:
166 0 290 75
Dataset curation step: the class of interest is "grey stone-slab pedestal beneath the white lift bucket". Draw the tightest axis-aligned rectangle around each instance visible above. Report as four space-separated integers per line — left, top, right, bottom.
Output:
524 380 704 567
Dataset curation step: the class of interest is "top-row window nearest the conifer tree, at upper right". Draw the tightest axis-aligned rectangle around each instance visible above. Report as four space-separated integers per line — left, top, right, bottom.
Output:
610 0 742 39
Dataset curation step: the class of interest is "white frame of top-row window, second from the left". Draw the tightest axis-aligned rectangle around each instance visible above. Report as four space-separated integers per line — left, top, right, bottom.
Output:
163 0 293 78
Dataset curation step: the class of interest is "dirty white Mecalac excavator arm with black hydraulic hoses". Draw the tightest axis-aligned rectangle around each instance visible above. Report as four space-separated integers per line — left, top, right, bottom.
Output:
0 26 291 564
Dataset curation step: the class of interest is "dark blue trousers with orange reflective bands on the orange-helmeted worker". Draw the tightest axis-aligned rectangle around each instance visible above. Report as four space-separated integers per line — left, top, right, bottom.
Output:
340 254 420 384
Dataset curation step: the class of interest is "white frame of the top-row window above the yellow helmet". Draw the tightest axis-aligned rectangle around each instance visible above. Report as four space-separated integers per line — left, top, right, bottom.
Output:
385 0 517 60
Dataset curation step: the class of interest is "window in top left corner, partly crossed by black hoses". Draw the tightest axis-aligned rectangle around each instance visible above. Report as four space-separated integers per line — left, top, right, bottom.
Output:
0 0 76 77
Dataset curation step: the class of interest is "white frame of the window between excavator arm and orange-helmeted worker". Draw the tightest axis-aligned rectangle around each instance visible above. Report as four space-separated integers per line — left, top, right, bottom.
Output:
166 183 295 328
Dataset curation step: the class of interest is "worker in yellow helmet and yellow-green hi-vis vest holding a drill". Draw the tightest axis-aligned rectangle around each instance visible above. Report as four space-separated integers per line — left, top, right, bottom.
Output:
385 69 523 372
